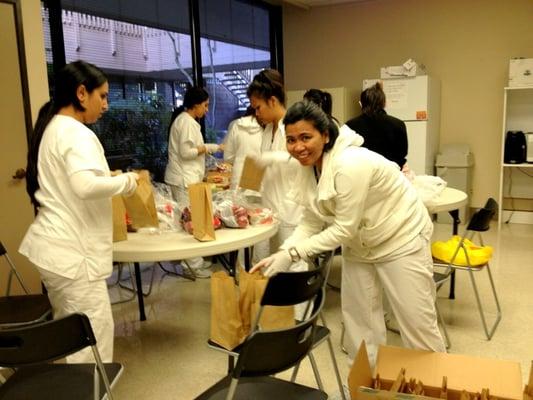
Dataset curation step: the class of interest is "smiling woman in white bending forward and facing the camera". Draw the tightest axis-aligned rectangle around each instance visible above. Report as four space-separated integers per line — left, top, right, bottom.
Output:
253 102 445 363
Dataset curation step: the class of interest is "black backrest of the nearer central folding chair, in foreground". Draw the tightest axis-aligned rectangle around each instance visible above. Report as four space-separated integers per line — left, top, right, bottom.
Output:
232 287 325 378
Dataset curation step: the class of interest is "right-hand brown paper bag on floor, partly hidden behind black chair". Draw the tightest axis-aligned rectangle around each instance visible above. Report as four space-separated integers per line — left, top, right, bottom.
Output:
251 274 295 330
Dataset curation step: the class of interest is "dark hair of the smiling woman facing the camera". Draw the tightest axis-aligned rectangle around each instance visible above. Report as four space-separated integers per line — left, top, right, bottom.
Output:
283 101 339 152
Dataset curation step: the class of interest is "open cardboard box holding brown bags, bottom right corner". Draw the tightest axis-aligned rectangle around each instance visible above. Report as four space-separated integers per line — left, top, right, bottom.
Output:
348 343 533 400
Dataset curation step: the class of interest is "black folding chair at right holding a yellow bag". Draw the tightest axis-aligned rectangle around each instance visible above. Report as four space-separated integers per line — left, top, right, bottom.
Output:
433 198 502 340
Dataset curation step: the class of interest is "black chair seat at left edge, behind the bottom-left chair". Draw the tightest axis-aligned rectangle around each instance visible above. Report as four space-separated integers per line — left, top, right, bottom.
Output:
0 294 52 325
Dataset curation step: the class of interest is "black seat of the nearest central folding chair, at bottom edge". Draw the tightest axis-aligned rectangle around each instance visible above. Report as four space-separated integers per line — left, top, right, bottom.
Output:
196 376 328 400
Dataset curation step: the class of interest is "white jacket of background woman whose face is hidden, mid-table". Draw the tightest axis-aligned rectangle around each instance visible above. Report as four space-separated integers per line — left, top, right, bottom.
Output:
224 115 263 189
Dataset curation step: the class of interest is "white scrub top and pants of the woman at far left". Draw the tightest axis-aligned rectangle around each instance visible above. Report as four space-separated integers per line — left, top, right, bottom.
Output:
19 115 119 362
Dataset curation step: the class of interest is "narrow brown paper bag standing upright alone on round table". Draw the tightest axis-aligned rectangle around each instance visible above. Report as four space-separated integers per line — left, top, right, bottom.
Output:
185 182 216 242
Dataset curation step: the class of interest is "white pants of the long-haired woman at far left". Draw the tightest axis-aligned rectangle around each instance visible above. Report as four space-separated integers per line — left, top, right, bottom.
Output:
38 267 115 364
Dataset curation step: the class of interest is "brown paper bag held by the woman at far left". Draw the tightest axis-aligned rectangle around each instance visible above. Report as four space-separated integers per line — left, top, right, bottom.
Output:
122 169 159 230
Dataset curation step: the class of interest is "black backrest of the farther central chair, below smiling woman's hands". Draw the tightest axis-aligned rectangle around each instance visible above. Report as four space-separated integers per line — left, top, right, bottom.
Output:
261 252 333 306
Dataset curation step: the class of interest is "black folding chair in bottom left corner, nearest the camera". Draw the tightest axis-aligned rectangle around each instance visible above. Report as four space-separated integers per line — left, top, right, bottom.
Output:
0 314 122 400
